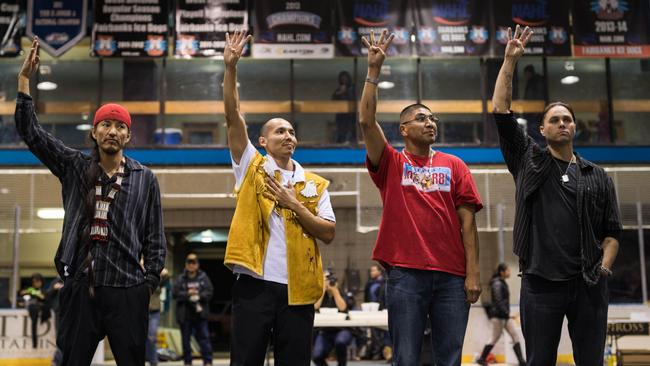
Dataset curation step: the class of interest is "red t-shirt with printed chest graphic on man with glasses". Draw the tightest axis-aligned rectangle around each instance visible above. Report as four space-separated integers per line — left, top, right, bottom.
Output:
366 144 483 276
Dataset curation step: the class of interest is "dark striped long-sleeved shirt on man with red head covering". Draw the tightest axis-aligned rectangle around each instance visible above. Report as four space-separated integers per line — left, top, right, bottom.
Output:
15 93 167 289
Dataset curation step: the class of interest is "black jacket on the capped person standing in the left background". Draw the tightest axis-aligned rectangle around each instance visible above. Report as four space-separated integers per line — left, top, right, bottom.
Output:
172 270 212 323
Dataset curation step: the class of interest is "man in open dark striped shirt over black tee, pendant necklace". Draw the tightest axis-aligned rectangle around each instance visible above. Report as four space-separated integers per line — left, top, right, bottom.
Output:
492 26 621 365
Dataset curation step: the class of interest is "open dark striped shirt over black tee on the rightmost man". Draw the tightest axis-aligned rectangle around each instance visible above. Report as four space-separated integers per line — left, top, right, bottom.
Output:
494 113 621 284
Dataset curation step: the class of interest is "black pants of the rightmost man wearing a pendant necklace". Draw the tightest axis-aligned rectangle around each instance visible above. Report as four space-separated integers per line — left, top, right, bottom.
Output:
520 275 609 366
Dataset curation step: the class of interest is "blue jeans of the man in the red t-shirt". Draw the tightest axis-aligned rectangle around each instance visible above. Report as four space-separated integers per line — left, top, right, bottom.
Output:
386 267 469 366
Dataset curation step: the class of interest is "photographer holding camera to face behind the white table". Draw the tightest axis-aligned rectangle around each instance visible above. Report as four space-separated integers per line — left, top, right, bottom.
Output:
312 269 352 366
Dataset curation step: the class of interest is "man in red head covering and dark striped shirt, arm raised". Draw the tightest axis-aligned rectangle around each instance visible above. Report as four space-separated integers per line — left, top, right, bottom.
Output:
15 39 166 366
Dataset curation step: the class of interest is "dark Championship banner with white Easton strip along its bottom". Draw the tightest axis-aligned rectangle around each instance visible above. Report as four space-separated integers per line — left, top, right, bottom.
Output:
248 0 334 58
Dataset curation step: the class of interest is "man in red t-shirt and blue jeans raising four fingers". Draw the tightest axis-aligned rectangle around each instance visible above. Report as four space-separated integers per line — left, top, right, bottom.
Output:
359 31 483 366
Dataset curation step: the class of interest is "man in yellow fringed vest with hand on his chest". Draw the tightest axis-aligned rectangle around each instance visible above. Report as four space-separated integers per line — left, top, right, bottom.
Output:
223 32 335 366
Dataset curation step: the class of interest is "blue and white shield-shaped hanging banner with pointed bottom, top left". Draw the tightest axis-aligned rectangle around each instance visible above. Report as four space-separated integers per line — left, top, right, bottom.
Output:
27 0 88 57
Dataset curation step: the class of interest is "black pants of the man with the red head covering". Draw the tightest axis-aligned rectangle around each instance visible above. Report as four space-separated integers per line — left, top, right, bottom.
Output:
57 278 149 366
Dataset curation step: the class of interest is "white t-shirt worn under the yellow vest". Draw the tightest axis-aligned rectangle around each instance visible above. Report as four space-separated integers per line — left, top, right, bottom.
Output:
230 141 336 284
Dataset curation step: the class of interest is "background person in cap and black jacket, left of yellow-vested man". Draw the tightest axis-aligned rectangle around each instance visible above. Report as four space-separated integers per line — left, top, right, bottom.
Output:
172 253 212 366
